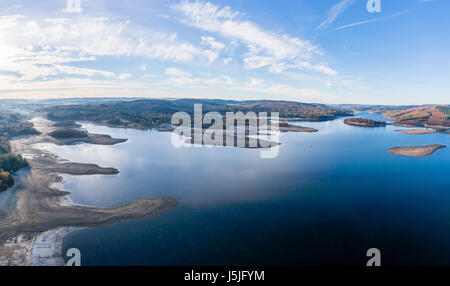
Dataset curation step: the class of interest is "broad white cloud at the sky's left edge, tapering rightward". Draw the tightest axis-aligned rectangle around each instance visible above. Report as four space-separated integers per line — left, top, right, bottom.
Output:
0 15 212 84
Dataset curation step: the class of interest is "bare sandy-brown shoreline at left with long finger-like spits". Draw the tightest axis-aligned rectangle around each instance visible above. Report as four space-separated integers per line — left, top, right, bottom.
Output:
0 120 178 265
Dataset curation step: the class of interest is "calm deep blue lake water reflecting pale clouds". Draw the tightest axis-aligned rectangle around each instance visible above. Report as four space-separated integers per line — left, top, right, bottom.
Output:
39 113 450 265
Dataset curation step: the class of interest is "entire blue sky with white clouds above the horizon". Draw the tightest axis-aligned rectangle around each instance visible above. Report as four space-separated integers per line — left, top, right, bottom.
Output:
0 0 450 105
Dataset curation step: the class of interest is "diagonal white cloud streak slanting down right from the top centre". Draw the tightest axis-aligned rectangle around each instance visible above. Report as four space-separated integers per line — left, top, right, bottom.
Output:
172 1 331 74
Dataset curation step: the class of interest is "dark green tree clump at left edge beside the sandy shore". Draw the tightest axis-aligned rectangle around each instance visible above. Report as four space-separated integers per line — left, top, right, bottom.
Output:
0 137 28 192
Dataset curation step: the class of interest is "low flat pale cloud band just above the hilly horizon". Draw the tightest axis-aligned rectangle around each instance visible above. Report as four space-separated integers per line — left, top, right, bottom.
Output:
0 75 336 102
